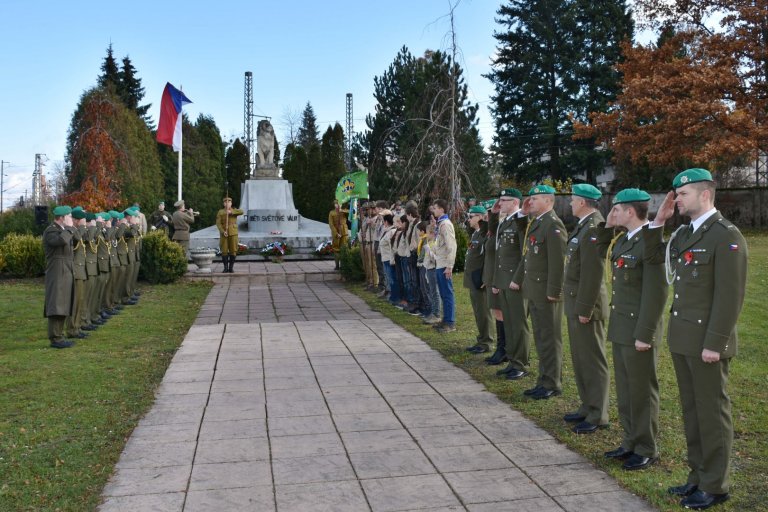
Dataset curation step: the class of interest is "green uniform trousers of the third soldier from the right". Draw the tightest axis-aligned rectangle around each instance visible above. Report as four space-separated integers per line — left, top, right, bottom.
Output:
566 315 610 425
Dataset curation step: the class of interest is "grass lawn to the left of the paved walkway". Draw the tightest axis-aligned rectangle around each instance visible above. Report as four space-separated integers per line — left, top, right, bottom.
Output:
0 280 210 511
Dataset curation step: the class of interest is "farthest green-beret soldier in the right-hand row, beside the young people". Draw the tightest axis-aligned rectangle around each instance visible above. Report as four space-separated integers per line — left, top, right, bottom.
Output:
463 206 493 354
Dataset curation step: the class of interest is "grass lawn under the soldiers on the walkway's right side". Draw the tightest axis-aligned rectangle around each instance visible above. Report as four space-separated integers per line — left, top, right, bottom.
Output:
351 234 768 512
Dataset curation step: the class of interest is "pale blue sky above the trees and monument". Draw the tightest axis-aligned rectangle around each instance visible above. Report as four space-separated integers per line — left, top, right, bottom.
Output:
0 0 501 207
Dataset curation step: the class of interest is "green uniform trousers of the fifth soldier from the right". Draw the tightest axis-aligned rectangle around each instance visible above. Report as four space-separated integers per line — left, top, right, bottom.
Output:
498 288 531 371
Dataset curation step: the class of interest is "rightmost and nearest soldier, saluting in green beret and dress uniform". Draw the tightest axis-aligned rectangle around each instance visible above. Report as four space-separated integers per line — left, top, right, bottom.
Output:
643 169 747 509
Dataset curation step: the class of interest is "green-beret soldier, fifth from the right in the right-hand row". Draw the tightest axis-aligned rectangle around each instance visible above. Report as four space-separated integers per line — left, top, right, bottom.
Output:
490 188 531 380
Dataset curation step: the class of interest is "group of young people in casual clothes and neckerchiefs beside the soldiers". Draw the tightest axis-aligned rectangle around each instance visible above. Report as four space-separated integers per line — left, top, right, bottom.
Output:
359 199 456 333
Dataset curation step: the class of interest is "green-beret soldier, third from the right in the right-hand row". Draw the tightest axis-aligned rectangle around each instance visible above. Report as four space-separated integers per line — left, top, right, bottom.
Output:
563 183 609 434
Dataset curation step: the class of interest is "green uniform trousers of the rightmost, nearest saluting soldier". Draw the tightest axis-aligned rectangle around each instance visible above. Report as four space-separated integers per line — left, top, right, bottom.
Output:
672 353 733 494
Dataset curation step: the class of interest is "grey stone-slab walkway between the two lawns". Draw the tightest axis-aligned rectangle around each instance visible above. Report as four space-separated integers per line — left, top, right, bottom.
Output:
100 281 653 512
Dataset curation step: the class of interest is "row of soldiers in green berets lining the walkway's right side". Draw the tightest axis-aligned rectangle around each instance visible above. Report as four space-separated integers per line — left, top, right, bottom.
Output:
465 169 747 509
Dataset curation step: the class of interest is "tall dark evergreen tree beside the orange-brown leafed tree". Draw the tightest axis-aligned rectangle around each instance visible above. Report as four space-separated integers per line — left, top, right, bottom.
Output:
487 0 633 180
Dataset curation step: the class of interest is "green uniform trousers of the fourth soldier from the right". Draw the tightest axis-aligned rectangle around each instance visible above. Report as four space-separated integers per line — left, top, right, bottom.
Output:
528 300 563 391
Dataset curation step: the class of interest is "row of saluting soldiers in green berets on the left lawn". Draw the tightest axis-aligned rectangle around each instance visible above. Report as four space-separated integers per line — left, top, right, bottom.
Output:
43 205 146 348
